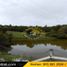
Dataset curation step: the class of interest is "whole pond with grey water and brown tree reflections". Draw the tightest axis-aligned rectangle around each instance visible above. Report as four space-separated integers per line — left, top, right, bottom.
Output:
8 40 67 60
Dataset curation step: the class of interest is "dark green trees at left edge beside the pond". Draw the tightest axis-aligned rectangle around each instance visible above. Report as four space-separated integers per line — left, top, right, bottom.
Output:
0 30 12 49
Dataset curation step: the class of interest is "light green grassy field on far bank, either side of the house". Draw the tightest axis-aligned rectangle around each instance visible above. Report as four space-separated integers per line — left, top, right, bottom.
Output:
7 31 46 39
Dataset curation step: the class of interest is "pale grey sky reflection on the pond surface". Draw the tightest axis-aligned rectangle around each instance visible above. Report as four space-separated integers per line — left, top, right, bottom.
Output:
9 44 67 59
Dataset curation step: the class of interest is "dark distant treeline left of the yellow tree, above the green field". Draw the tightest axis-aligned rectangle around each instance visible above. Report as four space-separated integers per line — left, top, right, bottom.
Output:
0 25 28 32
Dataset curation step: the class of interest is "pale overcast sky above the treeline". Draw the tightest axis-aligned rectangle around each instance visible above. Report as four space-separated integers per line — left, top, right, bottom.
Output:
0 0 67 26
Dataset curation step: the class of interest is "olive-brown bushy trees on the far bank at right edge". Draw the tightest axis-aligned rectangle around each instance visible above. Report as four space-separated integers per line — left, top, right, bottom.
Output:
45 25 67 39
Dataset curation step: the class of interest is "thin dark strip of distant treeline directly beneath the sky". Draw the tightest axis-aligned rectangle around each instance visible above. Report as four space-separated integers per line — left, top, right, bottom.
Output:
0 25 67 32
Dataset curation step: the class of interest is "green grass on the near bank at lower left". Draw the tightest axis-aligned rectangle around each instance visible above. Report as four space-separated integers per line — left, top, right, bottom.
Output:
0 52 34 61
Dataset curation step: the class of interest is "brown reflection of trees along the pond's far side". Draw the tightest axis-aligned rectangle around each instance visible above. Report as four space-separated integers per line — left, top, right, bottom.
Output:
14 39 67 49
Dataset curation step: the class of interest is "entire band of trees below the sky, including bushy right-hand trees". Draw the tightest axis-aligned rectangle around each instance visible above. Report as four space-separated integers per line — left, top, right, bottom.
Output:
0 25 67 39
